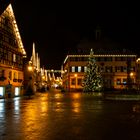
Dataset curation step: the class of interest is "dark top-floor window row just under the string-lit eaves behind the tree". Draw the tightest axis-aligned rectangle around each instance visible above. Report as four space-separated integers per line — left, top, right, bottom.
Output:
70 57 136 61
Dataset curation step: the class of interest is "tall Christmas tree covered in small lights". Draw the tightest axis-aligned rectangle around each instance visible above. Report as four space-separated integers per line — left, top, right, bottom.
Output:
83 49 103 92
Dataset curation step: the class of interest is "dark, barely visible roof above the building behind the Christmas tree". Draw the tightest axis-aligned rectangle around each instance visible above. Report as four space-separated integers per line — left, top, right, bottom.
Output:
68 41 136 55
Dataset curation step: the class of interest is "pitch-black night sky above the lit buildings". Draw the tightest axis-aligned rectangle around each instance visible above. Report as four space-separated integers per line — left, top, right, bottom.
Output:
9 0 140 69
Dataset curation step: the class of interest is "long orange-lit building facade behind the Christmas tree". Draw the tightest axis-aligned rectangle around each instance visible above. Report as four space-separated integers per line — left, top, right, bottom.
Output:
62 48 137 91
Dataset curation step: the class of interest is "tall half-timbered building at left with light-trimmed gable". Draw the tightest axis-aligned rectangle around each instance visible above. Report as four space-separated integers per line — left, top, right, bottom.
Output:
0 4 26 97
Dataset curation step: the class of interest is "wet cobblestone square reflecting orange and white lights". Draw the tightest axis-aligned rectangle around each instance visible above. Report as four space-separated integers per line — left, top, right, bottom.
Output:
0 91 140 140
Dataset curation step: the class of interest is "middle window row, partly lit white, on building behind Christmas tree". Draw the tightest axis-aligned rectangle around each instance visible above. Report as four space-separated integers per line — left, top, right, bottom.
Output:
70 66 135 72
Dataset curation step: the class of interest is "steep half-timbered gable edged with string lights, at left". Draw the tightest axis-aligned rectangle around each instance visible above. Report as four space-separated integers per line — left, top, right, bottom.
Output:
0 4 26 57
